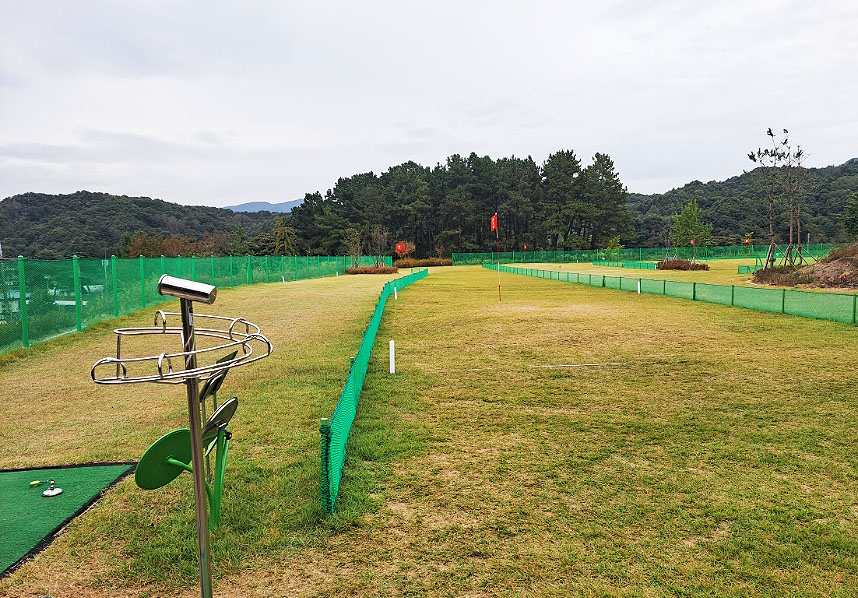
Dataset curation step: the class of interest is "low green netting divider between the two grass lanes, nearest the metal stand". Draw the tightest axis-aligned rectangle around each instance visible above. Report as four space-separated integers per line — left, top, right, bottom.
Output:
319 270 429 513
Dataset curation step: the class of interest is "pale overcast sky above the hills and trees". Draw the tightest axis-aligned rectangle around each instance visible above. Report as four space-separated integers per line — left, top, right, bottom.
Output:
0 0 858 206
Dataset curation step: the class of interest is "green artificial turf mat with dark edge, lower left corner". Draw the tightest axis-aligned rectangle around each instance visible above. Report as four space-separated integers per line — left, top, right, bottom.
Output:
0 463 134 576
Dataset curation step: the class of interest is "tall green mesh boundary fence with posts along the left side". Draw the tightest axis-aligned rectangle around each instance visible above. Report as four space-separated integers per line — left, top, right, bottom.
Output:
0 255 393 353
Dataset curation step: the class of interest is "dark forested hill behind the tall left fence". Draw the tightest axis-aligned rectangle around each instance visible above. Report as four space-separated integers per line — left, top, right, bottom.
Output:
0 191 275 259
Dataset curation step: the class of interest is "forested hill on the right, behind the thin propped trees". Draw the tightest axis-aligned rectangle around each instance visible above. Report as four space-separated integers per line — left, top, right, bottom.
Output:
629 159 858 247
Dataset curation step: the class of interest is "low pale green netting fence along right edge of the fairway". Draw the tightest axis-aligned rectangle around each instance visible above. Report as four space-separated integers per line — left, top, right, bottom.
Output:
483 264 858 324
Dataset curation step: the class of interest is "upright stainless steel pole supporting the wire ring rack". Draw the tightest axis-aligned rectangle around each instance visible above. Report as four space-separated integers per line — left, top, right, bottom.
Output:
180 298 212 598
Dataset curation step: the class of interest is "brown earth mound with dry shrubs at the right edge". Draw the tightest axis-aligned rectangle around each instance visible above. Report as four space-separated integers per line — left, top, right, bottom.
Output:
754 242 858 288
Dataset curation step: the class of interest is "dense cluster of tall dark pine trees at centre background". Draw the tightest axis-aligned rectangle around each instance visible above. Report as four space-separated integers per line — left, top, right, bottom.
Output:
288 150 634 257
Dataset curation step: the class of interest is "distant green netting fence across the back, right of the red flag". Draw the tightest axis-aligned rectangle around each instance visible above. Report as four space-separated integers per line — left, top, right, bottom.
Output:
453 243 836 266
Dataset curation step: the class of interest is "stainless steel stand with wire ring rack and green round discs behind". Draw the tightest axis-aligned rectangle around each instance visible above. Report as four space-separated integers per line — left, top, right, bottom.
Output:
90 274 273 598
